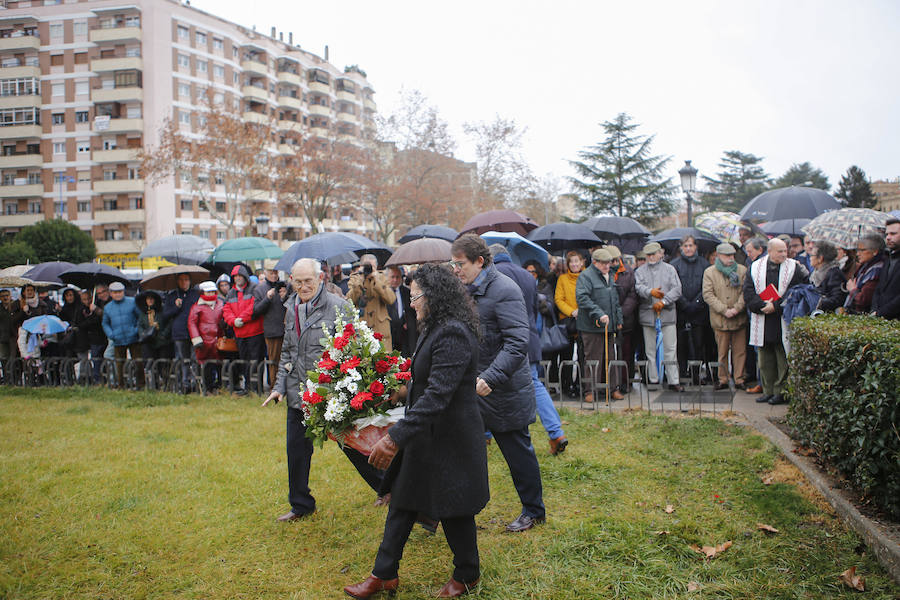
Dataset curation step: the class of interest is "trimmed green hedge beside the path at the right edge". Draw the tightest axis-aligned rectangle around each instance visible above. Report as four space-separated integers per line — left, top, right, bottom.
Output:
788 315 900 518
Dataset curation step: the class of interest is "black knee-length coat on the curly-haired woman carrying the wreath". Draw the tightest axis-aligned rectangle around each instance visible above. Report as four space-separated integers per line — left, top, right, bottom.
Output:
382 321 490 519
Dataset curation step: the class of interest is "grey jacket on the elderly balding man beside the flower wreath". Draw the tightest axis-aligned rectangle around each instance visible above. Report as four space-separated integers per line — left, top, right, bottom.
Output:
272 286 355 409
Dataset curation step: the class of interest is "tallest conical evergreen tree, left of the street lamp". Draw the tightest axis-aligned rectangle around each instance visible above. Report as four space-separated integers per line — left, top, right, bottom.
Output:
567 113 676 223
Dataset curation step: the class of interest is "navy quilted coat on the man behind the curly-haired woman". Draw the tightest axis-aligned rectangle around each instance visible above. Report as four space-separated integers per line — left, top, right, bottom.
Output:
470 265 535 432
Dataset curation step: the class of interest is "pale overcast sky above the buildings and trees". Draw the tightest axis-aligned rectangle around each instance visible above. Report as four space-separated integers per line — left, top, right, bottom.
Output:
192 0 900 192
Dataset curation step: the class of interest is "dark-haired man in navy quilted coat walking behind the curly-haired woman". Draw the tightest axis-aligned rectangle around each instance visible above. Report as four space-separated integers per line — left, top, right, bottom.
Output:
450 234 546 532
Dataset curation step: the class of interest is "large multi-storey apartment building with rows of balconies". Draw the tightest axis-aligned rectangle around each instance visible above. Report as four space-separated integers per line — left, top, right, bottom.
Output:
0 0 376 258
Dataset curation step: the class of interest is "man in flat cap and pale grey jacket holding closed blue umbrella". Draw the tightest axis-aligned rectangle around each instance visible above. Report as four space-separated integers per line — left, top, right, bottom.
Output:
634 242 684 392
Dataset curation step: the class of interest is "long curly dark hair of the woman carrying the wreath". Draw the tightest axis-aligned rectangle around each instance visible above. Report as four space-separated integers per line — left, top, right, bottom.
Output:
412 264 481 340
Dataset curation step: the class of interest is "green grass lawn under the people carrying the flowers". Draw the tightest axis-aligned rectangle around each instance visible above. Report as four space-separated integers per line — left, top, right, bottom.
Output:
0 388 900 600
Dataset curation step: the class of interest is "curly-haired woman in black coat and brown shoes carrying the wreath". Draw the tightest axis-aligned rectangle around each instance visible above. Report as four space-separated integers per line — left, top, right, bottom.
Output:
344 265 490 598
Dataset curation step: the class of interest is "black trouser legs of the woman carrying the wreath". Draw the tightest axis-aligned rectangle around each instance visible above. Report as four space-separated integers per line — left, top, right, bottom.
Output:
372 505 481 583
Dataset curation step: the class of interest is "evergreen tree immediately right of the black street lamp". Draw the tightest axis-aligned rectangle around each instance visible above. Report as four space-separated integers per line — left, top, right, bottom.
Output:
700 150 769 212
